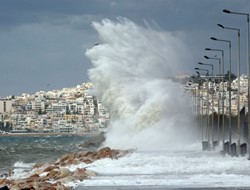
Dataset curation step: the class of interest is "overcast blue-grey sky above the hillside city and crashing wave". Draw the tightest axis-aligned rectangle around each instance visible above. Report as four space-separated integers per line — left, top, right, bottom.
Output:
0 0 250 97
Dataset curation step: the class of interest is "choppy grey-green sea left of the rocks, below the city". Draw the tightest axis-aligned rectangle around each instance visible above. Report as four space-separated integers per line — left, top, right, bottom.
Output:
0 135 91 174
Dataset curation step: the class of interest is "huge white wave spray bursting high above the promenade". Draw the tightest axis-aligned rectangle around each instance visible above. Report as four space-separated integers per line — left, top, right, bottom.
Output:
86 18 197 149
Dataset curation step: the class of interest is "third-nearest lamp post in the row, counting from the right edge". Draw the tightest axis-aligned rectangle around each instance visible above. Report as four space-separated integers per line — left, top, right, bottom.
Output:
210 37 232 153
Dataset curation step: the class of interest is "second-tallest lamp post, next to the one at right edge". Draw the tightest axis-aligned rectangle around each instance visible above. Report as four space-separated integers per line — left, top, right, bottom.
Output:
217 24 240 151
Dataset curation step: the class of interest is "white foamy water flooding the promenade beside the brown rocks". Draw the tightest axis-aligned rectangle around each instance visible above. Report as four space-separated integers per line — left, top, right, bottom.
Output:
73 143 250 189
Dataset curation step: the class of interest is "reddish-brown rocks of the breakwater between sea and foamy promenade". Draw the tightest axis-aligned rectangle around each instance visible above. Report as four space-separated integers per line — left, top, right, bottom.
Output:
0 147 131 190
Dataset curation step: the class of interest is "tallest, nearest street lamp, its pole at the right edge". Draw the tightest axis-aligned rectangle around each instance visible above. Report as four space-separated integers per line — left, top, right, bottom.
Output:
223 9 250 158
